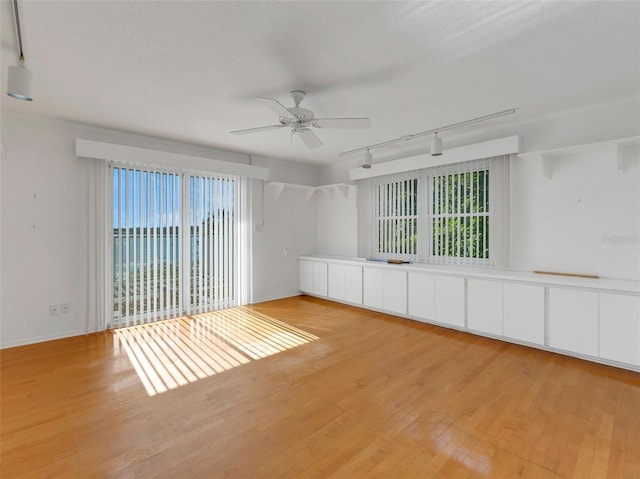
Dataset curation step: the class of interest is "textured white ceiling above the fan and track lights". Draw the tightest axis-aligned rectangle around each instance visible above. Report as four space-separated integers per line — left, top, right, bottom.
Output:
0 0 640 164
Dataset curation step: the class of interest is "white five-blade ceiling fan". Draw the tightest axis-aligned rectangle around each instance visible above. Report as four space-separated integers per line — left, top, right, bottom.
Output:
231 90 371 148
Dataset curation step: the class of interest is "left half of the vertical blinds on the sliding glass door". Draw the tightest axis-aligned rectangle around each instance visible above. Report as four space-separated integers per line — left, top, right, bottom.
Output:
113 166 182 326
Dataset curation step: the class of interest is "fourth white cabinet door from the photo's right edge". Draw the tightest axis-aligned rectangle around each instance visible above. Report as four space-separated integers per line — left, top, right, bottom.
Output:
467 279 502 336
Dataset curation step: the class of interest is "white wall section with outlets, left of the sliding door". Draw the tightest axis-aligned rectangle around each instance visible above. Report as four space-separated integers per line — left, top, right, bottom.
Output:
0 113 92 346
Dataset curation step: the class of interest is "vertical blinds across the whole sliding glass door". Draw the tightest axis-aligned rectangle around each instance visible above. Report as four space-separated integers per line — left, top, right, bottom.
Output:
111 164 239 326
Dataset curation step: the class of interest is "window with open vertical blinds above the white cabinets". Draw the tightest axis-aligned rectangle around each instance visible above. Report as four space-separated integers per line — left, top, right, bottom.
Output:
358 156 509 266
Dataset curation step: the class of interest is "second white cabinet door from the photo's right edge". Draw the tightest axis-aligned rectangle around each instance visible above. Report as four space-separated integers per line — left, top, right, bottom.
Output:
549 288 598 356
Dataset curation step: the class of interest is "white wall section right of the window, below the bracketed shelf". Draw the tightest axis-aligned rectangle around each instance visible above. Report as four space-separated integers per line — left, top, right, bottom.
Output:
511 146 640 280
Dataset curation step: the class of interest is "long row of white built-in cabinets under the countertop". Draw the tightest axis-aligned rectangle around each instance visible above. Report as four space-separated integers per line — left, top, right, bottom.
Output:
300 257 640 370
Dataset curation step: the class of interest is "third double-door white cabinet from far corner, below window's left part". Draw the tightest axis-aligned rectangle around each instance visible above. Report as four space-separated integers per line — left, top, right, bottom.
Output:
363 267 407 315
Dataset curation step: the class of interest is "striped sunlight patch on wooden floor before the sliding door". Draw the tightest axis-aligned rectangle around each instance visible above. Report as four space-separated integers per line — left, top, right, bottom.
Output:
114 307 318 396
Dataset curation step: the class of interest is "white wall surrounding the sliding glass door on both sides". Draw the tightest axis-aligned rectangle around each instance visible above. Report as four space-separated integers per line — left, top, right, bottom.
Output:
0 111 317 347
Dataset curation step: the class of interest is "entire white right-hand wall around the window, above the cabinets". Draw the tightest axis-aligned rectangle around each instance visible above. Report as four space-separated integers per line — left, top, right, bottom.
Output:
318 99 640 280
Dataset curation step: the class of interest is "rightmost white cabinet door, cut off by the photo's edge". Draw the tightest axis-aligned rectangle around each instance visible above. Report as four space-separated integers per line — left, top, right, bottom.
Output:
600 293 640 366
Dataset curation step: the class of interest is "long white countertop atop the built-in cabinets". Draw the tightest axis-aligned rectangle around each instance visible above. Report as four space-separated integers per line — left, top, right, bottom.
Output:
299 255 640 294
